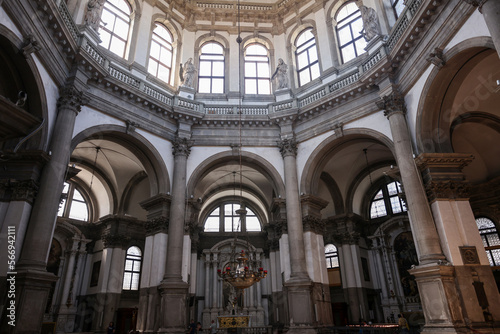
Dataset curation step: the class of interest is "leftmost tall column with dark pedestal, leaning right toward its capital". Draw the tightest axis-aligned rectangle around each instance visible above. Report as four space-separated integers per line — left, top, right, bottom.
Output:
1 85 84 334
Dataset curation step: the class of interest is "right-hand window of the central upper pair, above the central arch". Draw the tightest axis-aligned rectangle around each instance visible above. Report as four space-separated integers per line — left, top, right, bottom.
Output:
245 43 271 94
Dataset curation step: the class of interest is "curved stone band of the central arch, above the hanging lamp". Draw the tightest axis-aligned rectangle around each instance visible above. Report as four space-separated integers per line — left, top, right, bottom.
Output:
187 151 285 197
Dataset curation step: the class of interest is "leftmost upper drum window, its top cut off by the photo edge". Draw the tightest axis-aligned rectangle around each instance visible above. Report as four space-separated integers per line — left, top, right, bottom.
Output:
99 0 134 59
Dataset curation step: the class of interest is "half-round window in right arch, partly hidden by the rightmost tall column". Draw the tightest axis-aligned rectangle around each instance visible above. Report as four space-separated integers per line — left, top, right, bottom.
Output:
370 181 407 219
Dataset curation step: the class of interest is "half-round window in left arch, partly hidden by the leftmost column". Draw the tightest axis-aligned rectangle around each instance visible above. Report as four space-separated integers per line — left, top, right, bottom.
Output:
57 182 89 221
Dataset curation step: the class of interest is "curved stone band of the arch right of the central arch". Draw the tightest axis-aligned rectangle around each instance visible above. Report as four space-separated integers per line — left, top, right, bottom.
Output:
300 128 395 195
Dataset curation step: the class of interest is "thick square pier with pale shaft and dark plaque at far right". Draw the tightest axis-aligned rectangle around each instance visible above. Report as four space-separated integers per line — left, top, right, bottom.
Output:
413 153 500 331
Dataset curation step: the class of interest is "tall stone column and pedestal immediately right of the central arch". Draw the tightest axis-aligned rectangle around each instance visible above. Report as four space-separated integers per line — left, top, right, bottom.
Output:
278 138 315 333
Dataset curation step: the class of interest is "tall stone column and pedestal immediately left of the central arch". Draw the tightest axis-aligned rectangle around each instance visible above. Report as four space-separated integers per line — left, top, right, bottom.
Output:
159 137 192 333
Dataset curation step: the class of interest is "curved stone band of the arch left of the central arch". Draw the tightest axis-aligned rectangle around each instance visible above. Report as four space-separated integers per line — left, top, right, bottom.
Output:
71 125 170 196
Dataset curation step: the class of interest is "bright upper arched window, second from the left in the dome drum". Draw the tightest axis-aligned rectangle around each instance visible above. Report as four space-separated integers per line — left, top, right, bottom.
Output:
148 22 173 84
